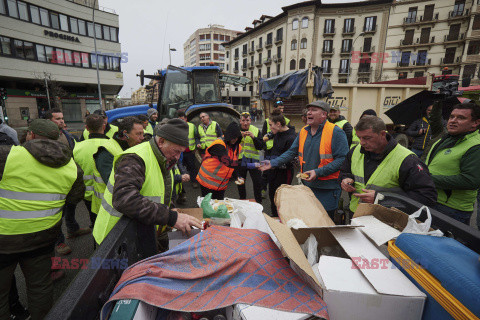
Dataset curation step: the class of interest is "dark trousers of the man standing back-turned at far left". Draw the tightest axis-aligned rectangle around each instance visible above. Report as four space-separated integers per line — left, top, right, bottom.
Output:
0 247 53 320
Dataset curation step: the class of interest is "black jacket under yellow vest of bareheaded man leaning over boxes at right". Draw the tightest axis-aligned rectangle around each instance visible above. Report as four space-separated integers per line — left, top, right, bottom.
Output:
339 135 437 206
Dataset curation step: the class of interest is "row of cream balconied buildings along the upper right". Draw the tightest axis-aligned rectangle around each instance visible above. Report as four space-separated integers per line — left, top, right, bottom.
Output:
225 0 480 97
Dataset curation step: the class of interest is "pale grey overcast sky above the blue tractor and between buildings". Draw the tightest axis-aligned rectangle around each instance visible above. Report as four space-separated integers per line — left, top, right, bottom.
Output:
99 0 364 97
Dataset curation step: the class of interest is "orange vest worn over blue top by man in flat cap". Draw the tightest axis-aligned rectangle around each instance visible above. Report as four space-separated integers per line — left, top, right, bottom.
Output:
298 121 340 180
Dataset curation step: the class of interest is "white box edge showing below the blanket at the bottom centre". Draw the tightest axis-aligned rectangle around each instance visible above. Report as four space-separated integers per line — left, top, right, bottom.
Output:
227 303 318 320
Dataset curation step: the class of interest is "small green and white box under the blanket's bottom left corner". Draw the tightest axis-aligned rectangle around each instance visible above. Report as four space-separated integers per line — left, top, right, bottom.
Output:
108 299 158 320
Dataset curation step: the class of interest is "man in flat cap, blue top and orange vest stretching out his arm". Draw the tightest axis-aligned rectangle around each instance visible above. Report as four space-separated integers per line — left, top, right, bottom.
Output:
260 101 349 219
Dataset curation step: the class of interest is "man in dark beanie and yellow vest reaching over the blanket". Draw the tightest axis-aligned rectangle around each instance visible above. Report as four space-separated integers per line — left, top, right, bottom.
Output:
93 119 202 244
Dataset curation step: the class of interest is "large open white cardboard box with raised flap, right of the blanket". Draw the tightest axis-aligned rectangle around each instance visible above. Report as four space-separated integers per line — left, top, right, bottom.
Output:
265 216 426 320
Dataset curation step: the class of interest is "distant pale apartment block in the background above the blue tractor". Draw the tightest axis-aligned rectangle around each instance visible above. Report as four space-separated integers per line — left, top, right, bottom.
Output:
183 24 241 69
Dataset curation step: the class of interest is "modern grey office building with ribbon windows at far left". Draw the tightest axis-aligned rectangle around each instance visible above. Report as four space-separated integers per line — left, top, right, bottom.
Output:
0 0 127 127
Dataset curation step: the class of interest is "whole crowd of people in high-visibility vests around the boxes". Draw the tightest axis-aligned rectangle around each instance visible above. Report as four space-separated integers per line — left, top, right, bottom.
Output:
0 101 480 319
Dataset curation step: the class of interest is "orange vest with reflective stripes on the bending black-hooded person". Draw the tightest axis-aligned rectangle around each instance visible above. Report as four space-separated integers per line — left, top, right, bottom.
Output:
197 139 242 191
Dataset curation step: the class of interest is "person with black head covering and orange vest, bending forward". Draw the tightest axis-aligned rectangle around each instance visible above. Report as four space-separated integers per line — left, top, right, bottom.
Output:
197 122 242 200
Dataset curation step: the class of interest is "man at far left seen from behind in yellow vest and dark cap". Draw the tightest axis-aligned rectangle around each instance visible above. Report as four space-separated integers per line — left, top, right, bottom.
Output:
0 119 85 319
